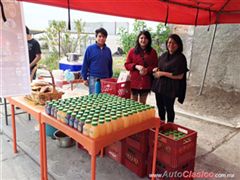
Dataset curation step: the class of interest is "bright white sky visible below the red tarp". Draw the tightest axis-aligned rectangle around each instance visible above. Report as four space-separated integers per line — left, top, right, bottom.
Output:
23 2 158 30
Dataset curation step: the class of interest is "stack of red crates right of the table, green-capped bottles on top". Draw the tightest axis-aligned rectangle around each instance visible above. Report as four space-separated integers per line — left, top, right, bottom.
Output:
148 123 197 180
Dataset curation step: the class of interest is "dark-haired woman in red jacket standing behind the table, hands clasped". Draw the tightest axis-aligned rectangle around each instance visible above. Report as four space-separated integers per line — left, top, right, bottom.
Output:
125 31 158 104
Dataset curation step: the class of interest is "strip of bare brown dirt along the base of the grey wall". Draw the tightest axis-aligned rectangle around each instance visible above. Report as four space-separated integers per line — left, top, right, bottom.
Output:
176 86 240 120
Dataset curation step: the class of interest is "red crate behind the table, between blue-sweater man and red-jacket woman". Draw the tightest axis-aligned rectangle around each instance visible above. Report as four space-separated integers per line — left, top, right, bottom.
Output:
101 78 131 98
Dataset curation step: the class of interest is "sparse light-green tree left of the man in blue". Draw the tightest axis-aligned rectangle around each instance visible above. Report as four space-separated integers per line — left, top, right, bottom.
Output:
40 20 87 69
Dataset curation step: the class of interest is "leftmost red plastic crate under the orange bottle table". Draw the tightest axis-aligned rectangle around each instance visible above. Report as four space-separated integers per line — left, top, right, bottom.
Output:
105 140 125 164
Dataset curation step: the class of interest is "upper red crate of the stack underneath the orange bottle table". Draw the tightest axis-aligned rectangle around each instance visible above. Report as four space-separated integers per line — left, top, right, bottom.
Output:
126 130 149 153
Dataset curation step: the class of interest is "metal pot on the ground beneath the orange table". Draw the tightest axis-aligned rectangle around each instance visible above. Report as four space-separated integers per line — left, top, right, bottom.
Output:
54 130 75 148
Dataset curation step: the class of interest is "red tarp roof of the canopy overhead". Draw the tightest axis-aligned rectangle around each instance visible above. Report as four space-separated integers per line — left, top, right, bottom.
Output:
19 0 240 25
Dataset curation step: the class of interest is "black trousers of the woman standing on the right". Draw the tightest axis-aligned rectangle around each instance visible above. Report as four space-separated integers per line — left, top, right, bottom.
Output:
155 93 175 122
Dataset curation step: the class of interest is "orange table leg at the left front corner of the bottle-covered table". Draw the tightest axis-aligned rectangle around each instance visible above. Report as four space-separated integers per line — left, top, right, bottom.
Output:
41 123 48 180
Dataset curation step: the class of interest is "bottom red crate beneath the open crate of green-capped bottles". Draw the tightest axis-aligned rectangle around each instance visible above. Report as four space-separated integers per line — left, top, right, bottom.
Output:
147 156 195 180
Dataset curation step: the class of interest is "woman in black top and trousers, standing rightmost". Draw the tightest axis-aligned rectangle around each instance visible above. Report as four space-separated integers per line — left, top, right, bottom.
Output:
152 34 188 122
